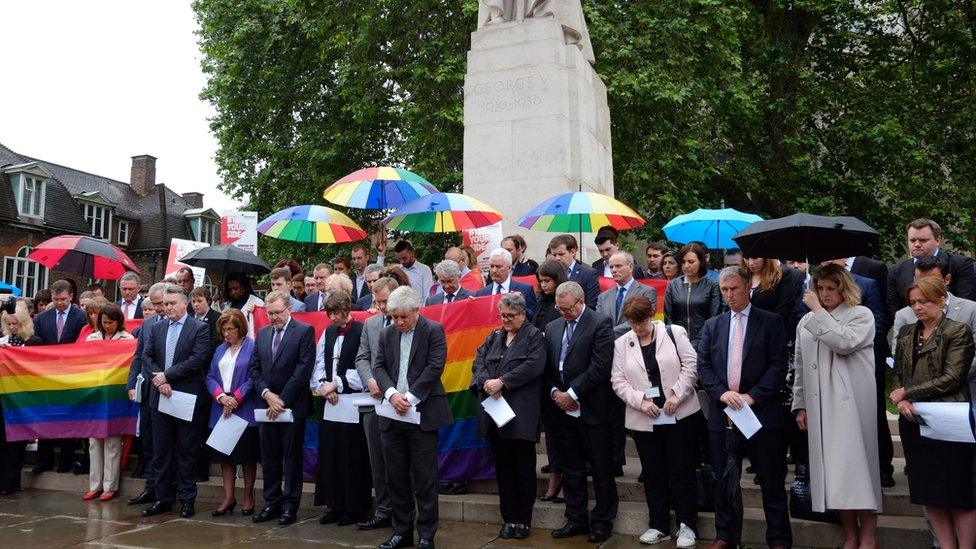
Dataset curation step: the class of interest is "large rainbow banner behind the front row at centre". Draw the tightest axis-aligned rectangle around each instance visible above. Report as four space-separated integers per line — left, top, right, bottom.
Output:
254 296 501 482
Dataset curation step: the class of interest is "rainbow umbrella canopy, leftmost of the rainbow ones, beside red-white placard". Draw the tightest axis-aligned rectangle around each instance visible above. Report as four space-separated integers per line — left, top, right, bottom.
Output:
258 205 366 244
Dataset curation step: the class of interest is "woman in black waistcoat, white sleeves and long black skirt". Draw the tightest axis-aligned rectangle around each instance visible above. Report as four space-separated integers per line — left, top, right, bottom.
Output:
309 292 373 526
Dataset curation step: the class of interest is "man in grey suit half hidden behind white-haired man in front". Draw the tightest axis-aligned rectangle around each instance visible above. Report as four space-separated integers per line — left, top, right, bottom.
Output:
356 276 398 530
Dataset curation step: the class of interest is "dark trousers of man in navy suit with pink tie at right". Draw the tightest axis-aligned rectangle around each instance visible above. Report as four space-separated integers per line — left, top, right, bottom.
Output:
708 428 793 548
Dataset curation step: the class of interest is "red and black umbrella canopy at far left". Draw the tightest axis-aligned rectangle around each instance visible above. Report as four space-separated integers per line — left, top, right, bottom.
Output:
27 236 139 280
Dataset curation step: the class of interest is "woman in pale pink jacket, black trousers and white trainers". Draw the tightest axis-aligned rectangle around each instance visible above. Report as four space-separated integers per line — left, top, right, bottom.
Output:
610 296 703 547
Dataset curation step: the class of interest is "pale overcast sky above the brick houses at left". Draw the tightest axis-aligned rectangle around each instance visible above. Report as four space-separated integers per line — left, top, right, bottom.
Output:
0 0 240 212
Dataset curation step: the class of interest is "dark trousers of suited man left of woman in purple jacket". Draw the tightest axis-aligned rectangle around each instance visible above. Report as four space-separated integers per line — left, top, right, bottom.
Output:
152 406 210 504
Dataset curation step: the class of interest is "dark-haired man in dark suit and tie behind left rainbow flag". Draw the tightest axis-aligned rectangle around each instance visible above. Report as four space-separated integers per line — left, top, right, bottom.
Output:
32 280 87 475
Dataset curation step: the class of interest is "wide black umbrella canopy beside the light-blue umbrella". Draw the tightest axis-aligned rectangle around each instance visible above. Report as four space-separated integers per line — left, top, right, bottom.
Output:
732 213 878 263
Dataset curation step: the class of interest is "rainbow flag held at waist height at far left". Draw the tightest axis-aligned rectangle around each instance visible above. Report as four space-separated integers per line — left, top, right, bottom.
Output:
0 340 139 440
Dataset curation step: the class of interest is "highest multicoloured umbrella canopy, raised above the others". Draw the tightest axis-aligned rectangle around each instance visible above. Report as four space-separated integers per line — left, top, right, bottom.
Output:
322 166 437 210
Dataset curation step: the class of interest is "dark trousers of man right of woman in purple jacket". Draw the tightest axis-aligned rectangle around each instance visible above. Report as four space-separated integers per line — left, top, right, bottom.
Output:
258 417 305 511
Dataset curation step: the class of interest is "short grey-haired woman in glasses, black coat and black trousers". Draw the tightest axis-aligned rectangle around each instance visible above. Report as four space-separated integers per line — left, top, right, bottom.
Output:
470 293 546 539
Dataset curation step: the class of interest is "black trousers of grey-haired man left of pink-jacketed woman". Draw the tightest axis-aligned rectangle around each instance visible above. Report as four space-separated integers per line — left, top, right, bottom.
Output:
546 414 619 530
